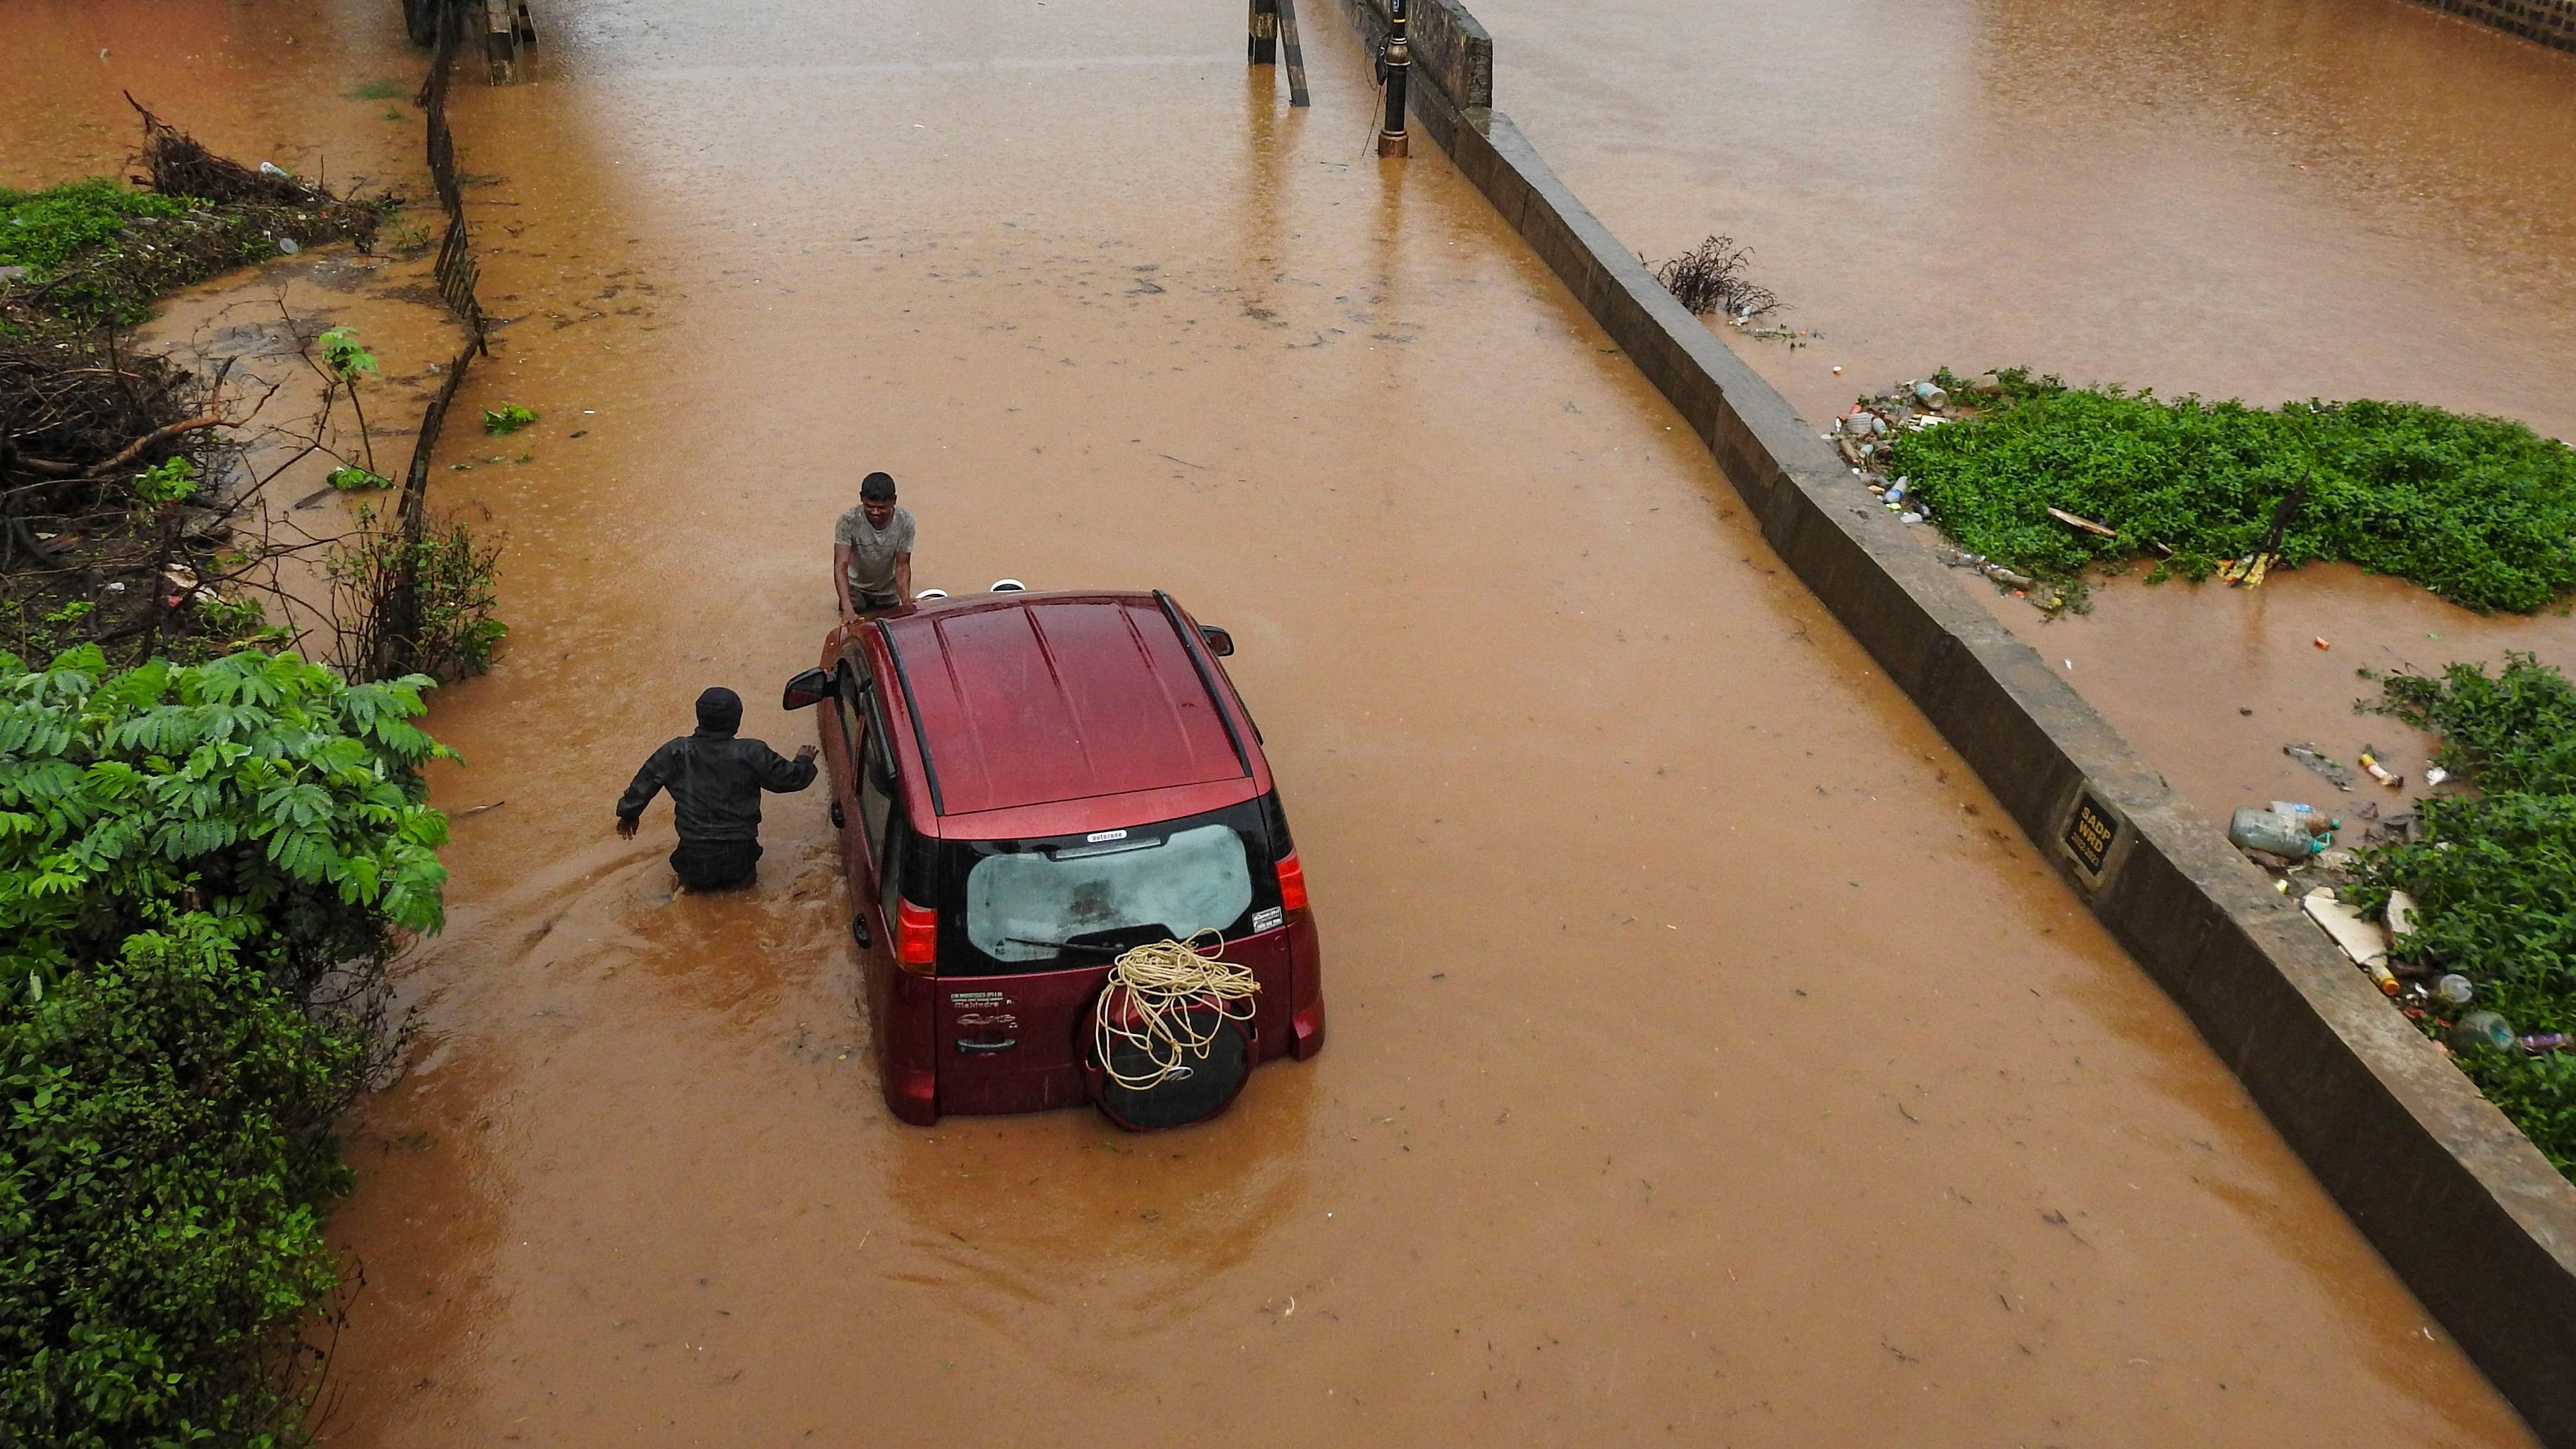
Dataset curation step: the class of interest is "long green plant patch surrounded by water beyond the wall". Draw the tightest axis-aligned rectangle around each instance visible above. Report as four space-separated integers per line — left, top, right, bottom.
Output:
1886 368 2576 613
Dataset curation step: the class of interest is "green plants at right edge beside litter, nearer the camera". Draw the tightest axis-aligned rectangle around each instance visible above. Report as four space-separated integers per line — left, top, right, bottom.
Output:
2359 655 2576 1178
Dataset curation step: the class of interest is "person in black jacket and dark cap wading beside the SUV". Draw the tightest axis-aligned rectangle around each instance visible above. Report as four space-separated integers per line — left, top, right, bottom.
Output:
618 688 814 889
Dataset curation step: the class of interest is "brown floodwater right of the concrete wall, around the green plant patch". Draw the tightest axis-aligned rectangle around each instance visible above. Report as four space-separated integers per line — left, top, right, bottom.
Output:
1471 0 2576 822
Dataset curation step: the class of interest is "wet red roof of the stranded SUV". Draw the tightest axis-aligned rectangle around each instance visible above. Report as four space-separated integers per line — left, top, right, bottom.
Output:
879 591 1268 836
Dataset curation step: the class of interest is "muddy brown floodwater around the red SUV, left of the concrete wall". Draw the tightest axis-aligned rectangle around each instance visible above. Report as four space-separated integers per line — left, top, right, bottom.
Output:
0 0 2524 1449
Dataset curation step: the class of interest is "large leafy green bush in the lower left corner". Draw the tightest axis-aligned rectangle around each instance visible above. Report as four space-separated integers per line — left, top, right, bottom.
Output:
0 647 445 1449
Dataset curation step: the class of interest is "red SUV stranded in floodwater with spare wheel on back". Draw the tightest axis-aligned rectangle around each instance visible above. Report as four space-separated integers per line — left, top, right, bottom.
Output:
786 591 1324 1126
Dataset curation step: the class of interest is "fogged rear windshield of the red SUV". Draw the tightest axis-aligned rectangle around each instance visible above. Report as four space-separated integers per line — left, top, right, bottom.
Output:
940 802 1277 975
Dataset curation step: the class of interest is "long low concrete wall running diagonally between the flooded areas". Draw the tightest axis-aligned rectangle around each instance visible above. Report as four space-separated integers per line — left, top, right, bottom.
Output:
1344 0 2576 1449
